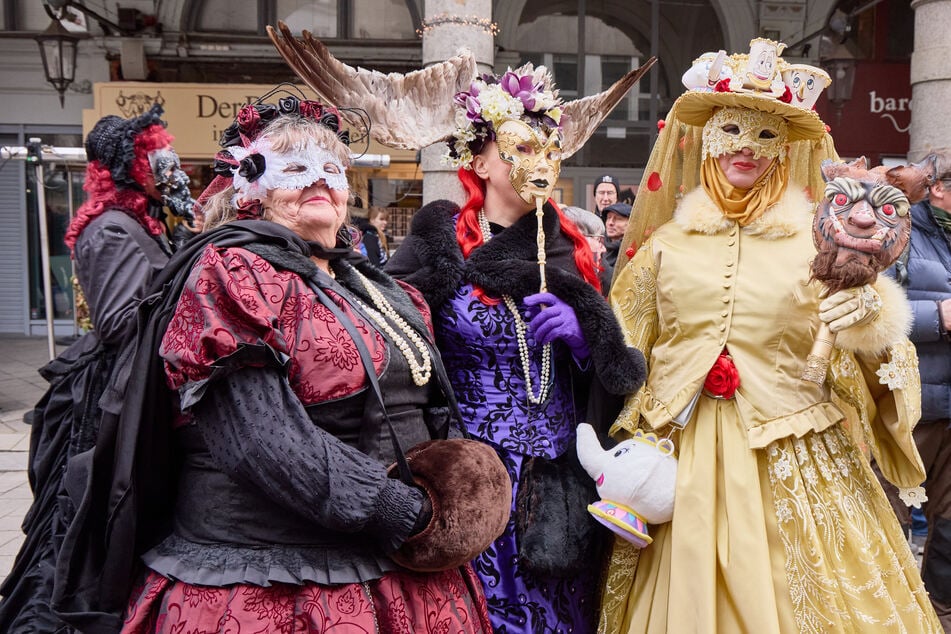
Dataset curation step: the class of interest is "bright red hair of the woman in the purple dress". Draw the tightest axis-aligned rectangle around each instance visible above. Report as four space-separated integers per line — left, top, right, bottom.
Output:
456 167 601 298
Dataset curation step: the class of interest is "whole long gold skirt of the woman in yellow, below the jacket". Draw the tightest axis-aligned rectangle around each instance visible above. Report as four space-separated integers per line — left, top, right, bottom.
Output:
599 397 942 634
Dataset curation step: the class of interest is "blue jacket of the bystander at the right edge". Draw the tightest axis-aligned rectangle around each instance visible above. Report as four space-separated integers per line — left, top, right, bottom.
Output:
903 201 951 423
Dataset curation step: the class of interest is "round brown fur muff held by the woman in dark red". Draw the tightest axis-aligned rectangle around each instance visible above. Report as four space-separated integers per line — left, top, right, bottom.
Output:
391 438 512 572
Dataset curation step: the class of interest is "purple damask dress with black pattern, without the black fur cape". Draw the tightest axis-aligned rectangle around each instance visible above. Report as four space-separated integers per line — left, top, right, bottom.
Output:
435 284 597 633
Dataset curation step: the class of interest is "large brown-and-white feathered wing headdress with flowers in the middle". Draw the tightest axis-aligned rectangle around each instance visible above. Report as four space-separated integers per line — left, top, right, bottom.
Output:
268 22 657 163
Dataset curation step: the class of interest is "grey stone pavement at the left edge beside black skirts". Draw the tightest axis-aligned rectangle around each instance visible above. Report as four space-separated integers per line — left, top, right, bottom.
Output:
0 335 57 581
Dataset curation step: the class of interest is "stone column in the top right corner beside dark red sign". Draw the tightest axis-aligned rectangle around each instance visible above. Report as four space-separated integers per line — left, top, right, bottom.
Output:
908 0 951 161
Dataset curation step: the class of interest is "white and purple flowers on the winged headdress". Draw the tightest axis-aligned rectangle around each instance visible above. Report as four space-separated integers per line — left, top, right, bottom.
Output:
443 64 562 167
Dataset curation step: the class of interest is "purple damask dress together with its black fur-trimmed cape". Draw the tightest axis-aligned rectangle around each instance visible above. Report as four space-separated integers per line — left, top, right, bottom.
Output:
386 200 645 634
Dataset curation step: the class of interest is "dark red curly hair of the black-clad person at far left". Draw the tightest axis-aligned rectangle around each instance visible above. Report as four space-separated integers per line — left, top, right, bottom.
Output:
64 124 173 251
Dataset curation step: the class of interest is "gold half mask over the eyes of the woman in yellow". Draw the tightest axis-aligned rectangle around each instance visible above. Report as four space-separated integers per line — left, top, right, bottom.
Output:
703 108 787 161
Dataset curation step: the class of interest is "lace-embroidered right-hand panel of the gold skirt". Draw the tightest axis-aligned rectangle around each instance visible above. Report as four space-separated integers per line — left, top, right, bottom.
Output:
767 426 940 634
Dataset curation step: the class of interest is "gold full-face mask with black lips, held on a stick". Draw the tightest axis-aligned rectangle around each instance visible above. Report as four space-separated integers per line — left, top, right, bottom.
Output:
495 119 561 203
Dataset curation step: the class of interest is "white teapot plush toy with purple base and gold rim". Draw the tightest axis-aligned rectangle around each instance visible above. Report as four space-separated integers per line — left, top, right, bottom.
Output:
577 423 677 548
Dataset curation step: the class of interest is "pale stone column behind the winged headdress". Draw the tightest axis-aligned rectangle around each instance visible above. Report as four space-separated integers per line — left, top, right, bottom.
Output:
422 0 495 204
